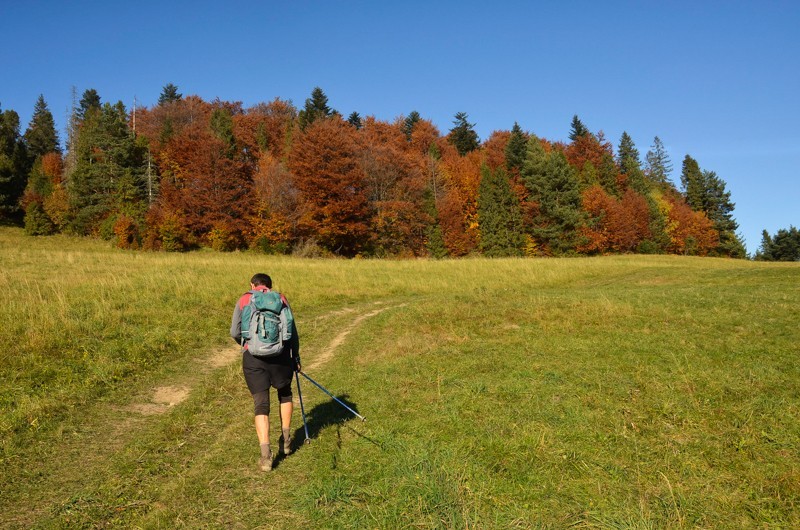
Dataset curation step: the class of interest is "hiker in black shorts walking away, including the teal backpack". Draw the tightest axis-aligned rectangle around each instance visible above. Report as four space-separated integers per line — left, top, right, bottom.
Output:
231 273 300 471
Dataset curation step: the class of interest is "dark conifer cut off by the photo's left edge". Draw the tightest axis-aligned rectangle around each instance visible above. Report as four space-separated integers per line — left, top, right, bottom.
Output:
0 110 30 221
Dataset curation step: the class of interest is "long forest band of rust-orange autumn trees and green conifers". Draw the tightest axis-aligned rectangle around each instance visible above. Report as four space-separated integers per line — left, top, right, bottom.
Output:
0 84 767 259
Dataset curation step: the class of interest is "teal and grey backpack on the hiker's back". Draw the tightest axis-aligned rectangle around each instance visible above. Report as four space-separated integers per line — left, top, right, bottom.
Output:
242 290 294 357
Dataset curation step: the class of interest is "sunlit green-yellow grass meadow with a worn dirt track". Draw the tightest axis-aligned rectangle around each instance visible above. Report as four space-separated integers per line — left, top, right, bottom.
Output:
0 228 800 528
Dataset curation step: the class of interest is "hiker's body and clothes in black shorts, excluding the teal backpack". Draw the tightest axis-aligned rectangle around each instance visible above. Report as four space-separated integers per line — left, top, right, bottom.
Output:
231 273 301 471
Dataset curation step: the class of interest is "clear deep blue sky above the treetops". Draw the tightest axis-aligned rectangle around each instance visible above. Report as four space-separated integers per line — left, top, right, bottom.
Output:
0 0 800 253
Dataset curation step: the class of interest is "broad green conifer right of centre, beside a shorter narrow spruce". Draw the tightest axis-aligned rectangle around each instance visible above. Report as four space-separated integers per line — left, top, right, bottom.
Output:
522 135 584 254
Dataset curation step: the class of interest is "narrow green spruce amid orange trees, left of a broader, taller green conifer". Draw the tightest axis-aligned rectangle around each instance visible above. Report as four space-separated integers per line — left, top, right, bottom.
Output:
478 165 525 257
